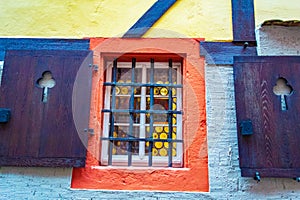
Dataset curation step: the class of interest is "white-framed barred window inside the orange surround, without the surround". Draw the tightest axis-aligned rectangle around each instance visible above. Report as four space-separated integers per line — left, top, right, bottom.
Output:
101 58 183 167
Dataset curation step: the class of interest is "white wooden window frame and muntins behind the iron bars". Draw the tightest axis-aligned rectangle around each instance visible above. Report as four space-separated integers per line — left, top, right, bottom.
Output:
100 60 183 167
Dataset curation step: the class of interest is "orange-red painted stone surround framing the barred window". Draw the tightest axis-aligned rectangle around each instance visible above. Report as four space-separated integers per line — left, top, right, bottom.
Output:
71 38 209 192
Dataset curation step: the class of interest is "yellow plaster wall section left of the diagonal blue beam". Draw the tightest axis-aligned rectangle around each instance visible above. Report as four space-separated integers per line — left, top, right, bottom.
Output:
0 0 155 38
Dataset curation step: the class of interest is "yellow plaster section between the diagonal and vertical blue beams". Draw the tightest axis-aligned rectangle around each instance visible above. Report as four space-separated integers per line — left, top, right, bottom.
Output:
145 0 233 41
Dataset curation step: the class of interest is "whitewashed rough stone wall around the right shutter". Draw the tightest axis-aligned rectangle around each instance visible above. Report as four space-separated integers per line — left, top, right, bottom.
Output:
206 27 300 199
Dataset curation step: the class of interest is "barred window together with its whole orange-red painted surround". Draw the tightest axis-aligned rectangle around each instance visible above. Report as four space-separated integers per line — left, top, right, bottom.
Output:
71 38 209 192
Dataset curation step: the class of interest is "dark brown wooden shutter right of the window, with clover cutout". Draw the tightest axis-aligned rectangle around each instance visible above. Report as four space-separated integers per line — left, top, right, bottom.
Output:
234 56 300 178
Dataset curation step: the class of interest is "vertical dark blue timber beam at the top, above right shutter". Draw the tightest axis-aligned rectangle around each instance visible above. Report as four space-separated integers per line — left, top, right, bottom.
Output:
231 0 256 42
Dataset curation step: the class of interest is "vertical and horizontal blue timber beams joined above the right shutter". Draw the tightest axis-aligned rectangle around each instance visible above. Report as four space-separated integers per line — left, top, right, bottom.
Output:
200 0 257 65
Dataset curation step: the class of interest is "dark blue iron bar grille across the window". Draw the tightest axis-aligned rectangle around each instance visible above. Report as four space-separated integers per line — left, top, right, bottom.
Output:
100 58 183 167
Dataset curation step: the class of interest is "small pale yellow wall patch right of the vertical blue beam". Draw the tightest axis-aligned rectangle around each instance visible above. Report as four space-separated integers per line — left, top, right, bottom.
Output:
254 0 300 26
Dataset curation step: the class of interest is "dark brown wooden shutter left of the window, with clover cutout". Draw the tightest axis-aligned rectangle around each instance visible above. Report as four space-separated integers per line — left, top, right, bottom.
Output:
0 50 92 167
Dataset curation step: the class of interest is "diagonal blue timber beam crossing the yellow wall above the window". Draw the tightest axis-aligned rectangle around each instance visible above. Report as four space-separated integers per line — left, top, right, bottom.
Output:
123 0 177 38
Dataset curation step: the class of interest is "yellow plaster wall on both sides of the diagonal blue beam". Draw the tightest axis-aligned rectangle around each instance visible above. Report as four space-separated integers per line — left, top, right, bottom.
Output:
0 0 232 40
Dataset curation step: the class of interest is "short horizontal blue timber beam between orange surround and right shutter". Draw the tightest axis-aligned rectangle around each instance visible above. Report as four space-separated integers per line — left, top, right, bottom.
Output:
200 42 257 65
